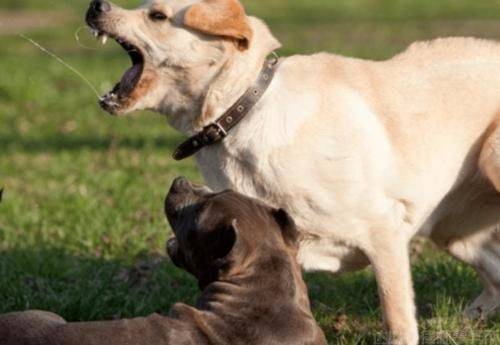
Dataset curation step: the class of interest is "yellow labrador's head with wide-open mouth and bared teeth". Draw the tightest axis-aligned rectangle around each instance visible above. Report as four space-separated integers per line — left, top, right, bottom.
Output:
86 0 279 123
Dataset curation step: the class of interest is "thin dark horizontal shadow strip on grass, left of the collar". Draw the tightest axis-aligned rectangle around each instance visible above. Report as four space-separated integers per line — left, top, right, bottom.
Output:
0 135 185 153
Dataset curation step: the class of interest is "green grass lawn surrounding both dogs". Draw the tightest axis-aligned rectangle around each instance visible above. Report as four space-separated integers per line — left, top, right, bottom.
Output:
0 0 500 345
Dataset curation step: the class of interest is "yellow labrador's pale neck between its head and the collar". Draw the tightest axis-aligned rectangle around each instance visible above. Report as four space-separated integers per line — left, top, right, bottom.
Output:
158 17 280 135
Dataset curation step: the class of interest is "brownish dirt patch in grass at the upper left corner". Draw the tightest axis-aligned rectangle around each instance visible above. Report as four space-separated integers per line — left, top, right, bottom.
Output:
0 11 73 35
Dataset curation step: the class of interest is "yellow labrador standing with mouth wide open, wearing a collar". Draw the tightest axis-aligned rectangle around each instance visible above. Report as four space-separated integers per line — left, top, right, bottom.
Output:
87 0 500 345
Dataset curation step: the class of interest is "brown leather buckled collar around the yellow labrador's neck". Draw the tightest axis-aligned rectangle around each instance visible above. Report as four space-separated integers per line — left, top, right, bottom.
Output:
173 57 278 161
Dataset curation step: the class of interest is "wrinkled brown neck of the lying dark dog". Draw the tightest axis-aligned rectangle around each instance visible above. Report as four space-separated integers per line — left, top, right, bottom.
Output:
170 245 322 344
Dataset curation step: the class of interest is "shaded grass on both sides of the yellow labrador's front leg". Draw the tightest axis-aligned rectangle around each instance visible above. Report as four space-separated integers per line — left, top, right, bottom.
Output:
306 257 481 318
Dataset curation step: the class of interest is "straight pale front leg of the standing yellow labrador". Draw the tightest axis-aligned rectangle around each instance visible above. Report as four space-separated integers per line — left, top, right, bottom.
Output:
366 231 418 345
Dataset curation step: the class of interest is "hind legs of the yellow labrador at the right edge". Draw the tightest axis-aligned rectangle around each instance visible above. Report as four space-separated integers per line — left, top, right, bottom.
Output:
431 119 500 318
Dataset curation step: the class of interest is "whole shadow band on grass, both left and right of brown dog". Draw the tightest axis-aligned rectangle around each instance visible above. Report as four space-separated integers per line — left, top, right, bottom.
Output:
0 246 490 320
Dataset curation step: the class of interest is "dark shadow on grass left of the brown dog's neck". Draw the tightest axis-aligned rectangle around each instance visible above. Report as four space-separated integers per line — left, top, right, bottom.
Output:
0 247 198 321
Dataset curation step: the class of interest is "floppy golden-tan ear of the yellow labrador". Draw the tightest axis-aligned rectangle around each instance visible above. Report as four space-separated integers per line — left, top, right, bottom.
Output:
184 0 252 50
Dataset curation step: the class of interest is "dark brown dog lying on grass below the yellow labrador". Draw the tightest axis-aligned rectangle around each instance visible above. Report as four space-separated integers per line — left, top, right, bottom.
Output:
0 178 326 345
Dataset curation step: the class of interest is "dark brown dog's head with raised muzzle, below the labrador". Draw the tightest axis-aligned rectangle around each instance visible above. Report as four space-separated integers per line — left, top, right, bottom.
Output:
165 178 298 289
